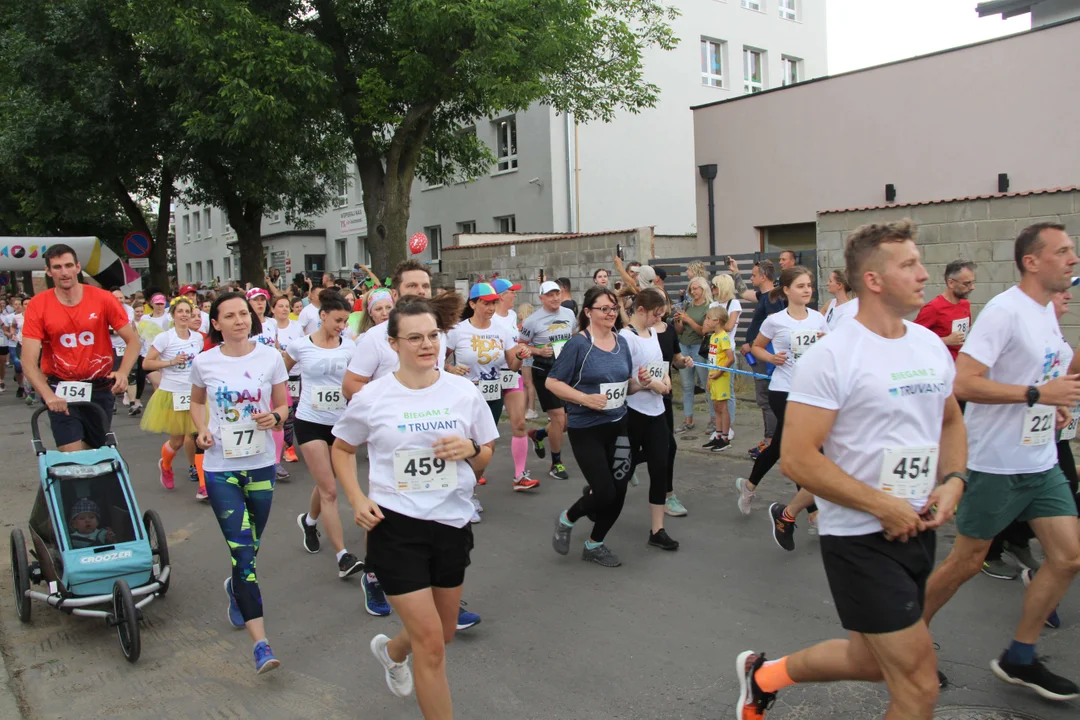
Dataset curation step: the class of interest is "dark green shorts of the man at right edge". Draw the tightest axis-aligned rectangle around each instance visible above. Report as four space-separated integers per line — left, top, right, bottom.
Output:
956 465 1077 540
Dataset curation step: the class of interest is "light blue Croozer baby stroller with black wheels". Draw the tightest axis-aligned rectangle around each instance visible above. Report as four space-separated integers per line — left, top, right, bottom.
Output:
11 403 171 663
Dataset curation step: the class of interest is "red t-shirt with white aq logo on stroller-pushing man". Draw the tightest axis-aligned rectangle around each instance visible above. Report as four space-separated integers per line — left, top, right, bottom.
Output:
23 285 130 380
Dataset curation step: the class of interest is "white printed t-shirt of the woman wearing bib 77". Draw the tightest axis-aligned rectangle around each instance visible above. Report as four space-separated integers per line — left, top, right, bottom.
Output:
191 342 288 473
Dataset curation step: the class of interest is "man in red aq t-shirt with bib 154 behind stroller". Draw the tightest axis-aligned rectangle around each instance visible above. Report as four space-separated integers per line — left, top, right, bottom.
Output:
23 244 139 452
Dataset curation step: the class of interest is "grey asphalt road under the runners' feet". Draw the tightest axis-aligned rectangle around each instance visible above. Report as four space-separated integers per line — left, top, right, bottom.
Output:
0 390 1080 720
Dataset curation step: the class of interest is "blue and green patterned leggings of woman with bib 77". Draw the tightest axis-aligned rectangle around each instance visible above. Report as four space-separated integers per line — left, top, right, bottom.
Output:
206 465 275 622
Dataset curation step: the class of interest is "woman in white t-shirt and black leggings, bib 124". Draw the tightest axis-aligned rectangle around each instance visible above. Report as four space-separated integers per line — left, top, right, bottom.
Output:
735 266 828 520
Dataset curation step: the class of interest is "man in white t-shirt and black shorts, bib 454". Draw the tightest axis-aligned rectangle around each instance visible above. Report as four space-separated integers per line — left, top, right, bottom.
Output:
735 220 967 720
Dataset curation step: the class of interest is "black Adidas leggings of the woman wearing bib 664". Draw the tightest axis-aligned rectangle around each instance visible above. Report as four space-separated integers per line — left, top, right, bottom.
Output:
566 418 633 543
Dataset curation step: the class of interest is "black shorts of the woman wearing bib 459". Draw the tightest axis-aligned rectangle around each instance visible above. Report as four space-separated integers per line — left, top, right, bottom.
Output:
364 507 473 596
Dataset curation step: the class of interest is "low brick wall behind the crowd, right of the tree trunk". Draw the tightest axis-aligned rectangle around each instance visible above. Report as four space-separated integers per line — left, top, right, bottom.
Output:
434 228 652 305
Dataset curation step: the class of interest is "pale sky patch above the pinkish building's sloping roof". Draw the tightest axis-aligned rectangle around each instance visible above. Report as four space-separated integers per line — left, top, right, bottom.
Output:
825 0 1031 74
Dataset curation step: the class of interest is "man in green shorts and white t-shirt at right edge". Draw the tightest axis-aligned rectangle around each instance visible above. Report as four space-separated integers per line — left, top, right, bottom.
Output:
926 222 1080 701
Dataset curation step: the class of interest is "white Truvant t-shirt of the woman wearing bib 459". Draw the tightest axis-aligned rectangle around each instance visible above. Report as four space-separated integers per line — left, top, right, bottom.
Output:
334 371 499 528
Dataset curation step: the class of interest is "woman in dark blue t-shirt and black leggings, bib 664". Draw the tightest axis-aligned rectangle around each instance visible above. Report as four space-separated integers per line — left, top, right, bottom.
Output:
546 285 650 568
